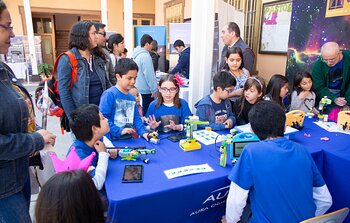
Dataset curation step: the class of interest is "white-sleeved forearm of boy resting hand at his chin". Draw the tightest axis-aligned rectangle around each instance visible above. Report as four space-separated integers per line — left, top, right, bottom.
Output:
92 152 109 190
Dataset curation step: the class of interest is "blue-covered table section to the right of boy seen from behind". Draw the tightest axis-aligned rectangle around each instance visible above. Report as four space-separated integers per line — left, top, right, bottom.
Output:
290 118 350 223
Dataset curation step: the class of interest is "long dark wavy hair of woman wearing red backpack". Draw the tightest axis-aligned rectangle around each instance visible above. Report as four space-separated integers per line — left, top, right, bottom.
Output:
68 21 106 60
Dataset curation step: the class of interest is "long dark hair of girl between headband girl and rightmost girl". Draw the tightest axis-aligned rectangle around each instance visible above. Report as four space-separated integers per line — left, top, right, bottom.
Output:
266 74 288 108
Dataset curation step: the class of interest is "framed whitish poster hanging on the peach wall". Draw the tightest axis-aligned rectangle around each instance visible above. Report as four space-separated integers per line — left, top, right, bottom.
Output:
259 0 292 54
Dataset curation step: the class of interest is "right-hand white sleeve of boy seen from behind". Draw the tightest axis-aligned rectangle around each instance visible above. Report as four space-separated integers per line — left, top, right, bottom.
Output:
312 184 332 216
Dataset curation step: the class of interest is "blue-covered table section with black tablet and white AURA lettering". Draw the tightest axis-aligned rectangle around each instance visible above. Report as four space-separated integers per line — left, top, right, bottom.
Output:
105 136 232 223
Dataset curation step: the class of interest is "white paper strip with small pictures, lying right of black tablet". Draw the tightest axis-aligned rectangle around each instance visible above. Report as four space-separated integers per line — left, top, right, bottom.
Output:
164 163 214 179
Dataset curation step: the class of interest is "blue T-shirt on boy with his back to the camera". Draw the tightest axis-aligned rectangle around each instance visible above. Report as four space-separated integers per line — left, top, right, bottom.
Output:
229 137 325 223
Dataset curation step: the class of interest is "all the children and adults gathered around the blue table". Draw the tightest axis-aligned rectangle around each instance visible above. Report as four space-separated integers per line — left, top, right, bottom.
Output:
0 0 350 222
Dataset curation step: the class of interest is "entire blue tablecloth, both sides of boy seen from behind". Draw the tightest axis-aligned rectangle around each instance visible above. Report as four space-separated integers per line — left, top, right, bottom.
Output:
105 118 350 223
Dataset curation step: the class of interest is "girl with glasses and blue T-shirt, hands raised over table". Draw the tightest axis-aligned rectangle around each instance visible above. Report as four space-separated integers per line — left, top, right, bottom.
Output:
146 74 191 132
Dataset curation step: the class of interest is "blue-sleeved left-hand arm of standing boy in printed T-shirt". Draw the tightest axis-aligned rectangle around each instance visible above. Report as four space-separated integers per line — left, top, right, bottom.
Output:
100 91 123 137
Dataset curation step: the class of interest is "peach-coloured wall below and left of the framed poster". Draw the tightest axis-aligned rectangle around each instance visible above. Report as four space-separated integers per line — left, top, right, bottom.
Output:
256 0 287 81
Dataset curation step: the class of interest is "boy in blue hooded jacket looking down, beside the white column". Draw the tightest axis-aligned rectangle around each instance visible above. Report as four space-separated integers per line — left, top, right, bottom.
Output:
195 71 236 131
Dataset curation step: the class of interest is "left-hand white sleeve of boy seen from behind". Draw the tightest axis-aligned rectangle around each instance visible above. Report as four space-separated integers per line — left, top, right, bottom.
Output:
226 182 249 223
